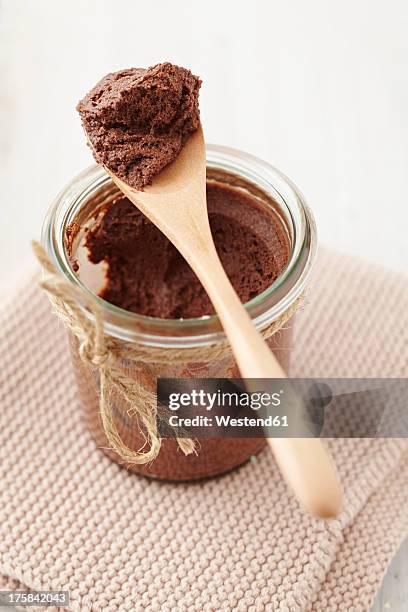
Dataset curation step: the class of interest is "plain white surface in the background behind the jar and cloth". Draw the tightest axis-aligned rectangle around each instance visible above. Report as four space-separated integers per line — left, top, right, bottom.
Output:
0 0 408 611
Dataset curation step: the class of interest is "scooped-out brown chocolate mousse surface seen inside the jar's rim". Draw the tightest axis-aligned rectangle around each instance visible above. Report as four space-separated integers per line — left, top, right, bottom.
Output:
86 181 290 319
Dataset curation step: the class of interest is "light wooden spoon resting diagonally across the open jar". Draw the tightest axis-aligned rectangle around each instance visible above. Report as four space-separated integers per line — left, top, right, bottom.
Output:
105 127 341 517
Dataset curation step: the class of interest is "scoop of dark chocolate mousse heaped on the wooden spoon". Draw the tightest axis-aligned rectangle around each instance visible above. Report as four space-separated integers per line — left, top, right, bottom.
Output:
77 62 201 190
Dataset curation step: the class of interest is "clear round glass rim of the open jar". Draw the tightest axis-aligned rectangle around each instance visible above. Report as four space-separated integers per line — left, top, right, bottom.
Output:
42 145 317 348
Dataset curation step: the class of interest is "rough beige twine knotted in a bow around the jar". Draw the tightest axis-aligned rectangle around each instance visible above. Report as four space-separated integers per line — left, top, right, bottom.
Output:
32 241 303 465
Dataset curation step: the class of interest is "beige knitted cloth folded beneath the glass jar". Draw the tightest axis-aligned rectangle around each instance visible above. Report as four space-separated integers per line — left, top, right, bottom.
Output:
0 253 408 612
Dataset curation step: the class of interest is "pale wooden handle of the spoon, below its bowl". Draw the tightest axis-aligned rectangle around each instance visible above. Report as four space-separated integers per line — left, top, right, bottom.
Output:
188 248 341 518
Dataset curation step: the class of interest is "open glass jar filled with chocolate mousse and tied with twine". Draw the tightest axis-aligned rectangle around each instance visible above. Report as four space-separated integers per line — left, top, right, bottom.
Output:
42 145 316 481
